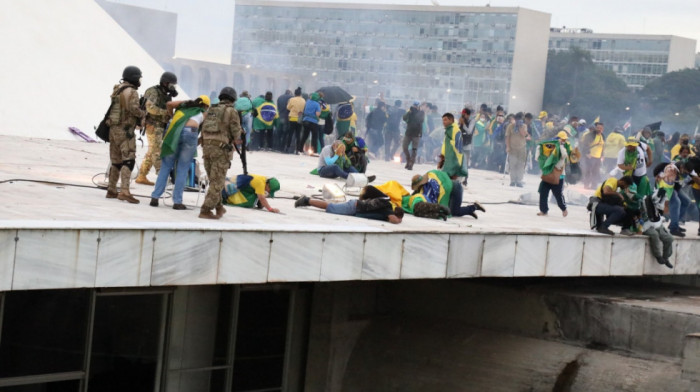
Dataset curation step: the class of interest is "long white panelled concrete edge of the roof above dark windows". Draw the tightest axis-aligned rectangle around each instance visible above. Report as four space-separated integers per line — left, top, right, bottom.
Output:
0 228 700 291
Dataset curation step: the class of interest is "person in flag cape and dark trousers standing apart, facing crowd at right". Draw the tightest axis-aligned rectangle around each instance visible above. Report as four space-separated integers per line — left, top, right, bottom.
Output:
537 131 572 217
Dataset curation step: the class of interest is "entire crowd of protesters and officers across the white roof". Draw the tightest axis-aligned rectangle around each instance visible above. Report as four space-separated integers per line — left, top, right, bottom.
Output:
101 66 700 242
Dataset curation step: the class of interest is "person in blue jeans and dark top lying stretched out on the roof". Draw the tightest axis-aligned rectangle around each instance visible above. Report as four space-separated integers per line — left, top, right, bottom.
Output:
294 185 403 224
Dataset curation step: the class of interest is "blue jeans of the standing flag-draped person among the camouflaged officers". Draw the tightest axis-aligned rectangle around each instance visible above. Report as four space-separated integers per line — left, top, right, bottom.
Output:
151 127 198 204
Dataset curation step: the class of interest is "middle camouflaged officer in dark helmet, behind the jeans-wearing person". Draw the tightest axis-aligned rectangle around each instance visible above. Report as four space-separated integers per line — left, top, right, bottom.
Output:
136 72 177 185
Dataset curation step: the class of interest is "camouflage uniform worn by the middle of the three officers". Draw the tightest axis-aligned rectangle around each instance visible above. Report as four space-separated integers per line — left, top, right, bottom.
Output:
139 85 172 177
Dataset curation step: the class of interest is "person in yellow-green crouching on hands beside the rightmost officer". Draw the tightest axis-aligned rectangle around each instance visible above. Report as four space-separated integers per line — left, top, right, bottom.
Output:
221 174 280 213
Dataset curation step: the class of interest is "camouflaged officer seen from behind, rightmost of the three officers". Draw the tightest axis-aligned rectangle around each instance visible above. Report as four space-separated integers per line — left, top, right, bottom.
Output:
199 87 243 219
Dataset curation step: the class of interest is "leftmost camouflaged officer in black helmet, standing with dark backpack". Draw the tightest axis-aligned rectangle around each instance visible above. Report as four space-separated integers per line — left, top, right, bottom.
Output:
106 65 146 204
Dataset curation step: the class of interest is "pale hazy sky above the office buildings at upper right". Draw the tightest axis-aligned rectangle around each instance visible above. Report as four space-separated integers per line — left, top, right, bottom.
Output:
278 0 700 51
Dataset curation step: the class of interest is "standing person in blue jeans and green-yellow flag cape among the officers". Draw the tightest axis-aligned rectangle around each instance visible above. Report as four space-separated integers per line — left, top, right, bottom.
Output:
150 95 210 210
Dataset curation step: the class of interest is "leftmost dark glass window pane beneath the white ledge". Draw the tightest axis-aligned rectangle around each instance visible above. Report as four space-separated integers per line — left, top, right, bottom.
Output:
0 290 90 377
